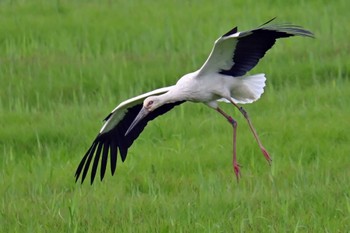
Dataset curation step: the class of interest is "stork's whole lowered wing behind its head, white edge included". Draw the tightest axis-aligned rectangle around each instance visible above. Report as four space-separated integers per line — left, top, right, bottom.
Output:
75 87 185 184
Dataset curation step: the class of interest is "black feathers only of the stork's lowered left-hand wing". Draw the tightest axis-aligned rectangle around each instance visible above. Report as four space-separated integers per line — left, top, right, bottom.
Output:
75 101 185 184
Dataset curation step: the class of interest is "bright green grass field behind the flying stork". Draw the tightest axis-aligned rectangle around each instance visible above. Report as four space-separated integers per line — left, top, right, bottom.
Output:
0 0 350 233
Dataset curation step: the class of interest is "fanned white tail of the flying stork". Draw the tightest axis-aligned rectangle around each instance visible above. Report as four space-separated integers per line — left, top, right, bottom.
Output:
231 74 266 104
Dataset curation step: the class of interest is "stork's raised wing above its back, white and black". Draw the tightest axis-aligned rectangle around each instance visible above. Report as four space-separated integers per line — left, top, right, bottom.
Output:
198 19 313 77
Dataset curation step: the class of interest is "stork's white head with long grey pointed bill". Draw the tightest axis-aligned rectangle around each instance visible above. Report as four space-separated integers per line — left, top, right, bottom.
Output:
125 96 162 135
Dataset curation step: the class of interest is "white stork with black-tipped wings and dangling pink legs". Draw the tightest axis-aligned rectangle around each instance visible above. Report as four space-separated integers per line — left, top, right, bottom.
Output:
75 19 313 184
